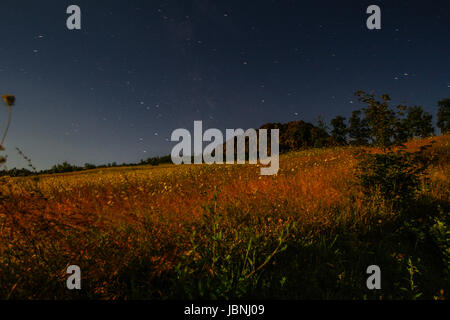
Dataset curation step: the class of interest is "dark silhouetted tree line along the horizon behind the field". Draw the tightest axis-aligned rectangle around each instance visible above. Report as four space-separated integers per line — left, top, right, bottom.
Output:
0 91 450 177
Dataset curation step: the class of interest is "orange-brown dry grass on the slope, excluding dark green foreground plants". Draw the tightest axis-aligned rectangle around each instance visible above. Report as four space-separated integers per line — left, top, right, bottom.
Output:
0 136 450 298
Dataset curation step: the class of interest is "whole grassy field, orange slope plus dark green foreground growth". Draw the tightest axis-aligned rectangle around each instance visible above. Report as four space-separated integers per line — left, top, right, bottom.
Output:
0 136 450 299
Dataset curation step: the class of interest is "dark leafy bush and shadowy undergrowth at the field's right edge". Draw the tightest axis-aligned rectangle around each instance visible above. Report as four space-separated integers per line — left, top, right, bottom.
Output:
358 146 450 300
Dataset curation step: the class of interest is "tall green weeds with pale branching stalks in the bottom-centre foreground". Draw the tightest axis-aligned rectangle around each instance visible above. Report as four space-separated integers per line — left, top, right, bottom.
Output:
167 191 295 299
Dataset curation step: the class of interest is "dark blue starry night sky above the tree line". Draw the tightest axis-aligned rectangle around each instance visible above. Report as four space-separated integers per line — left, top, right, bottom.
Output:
0 0 450 169
